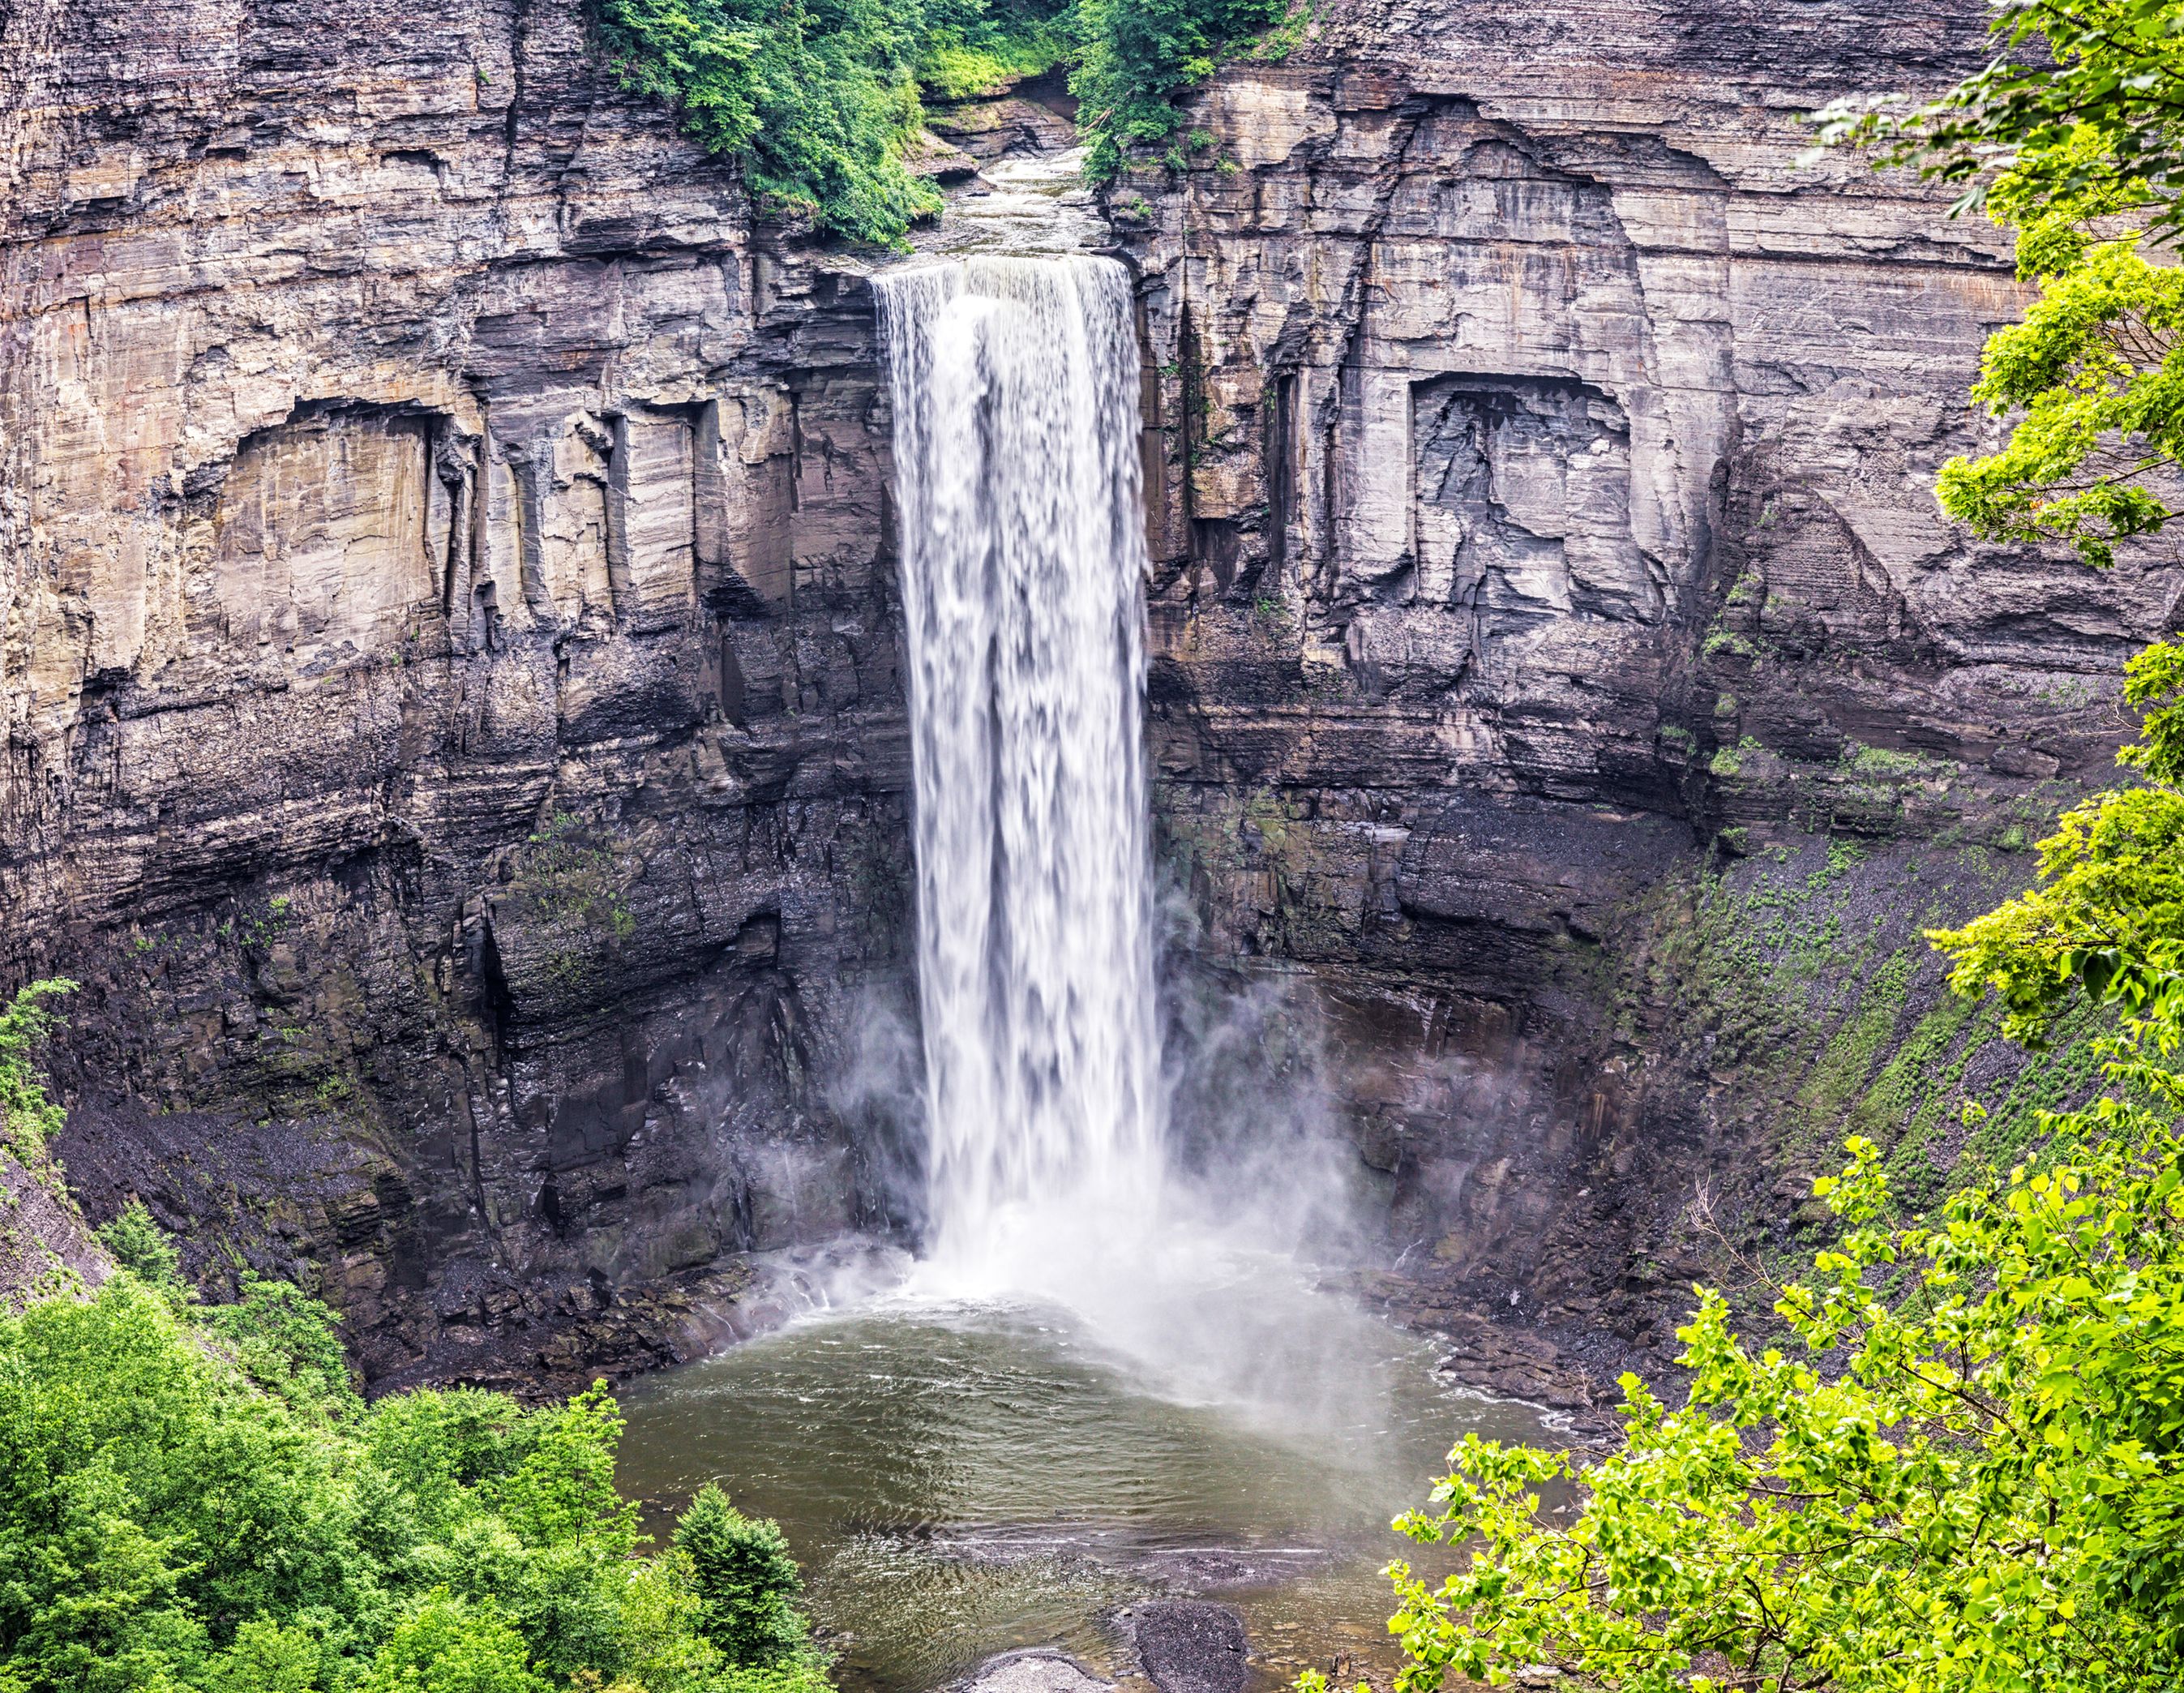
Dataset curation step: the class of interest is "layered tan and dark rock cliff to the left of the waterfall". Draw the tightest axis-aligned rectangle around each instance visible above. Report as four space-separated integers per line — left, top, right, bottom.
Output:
0 0 906 1376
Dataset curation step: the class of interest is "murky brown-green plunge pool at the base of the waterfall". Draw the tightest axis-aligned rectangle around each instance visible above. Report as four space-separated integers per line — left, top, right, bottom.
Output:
623 1265 1552 1693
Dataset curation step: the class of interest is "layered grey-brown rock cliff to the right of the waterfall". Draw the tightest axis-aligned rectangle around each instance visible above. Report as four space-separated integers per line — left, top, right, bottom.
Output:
1111 4 2178 1354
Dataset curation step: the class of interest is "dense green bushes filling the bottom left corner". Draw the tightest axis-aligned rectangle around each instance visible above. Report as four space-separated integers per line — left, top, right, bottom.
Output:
0 1275 825 1693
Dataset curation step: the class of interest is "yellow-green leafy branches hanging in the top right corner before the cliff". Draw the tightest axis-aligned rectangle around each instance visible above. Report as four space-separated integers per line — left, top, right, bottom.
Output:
1822 0 2184 566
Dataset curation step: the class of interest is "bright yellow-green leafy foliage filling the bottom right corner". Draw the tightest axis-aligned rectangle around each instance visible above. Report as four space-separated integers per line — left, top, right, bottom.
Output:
1363 1105 2184 1693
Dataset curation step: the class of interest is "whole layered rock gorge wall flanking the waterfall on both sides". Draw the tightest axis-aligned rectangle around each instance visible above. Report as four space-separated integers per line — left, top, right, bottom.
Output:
0 0 2175 1381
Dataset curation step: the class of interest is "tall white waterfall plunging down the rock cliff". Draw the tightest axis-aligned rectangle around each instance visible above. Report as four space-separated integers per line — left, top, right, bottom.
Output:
874 255 1162 1287
